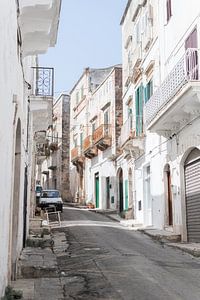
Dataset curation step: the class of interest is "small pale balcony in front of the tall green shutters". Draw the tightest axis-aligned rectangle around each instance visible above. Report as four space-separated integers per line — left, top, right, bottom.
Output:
118 116 144 158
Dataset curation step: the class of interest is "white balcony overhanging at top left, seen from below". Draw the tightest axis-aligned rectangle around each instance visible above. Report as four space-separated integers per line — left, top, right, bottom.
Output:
19 0 61 56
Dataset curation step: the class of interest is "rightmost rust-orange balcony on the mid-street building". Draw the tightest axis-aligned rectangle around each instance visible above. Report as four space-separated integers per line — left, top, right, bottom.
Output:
93 124 112 151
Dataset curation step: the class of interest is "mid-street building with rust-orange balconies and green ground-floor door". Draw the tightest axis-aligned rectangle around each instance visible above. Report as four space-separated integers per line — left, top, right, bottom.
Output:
70 66 122 209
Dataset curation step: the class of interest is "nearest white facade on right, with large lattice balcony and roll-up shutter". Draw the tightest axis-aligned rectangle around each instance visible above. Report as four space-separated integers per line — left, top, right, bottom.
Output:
145 1 200 242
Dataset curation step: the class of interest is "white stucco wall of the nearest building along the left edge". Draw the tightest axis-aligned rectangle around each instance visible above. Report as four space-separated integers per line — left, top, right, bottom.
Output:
0 1 36 296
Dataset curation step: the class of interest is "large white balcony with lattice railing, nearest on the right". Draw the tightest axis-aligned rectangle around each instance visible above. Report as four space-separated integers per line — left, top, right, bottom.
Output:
145 49 200 137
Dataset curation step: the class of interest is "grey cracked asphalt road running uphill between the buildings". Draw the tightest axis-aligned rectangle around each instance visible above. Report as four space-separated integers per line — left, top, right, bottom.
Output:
52 208 200 300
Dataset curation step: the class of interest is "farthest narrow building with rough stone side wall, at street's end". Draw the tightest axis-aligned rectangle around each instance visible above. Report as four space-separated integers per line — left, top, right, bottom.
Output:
37 94 71 201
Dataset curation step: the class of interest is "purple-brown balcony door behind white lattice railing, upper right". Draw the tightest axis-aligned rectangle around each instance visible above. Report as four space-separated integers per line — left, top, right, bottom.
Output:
185 28 199 80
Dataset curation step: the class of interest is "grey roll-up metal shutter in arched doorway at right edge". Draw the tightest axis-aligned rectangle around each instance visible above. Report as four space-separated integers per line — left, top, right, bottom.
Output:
185 159 200 242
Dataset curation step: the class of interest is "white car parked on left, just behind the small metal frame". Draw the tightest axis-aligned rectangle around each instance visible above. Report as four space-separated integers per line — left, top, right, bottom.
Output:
39 190 63 212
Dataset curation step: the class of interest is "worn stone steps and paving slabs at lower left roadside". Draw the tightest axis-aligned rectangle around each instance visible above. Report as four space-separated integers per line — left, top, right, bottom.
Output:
12 232 68 300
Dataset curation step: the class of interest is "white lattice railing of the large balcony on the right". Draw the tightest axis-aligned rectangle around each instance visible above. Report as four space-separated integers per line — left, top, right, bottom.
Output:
145 48 200 126
